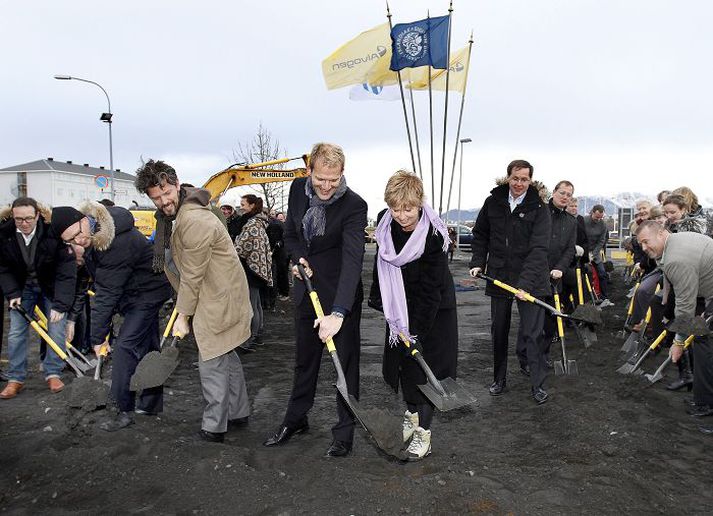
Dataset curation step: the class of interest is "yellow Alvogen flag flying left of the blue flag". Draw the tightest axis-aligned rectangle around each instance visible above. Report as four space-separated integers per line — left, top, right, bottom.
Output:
322 23 393 90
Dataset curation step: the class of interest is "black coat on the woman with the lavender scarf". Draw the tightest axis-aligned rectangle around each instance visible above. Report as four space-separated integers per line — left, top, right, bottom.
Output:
369 211 458 403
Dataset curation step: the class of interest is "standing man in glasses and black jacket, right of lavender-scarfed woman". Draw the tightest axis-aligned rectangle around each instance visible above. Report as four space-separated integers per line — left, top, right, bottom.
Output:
470 160 552 404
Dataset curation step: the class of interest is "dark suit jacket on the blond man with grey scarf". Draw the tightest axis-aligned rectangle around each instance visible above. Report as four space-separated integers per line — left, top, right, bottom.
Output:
285 178 367 314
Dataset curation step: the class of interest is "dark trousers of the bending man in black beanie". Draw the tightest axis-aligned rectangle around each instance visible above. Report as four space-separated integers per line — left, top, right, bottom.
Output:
111 301 163 412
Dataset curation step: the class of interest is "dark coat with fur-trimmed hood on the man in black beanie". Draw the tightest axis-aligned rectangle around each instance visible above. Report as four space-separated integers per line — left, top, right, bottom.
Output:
82 203 171 346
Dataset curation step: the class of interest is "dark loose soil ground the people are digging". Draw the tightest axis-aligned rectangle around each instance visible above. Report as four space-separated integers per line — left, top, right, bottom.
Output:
0 245 713 515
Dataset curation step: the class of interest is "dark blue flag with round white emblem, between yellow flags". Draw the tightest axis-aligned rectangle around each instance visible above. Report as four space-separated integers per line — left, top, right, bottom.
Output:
390 16 450 71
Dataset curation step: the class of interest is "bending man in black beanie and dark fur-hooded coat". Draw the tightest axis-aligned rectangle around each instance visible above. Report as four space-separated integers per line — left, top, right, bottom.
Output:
52 201 171 432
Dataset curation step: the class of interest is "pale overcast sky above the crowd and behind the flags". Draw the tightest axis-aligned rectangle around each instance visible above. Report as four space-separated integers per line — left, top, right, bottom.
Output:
0 0 713 215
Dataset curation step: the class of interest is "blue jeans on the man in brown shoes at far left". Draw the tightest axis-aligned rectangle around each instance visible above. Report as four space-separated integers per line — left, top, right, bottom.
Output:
7 286 67 383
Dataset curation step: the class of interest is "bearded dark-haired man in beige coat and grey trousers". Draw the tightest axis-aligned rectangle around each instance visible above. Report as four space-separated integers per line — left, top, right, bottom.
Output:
135 160 252 442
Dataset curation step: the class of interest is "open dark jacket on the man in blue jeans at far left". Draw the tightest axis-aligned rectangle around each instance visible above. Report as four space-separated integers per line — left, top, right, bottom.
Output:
0 212 77 310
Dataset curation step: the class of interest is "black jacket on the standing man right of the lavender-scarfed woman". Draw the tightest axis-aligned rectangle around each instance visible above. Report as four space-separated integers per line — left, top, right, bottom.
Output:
470 184 552 297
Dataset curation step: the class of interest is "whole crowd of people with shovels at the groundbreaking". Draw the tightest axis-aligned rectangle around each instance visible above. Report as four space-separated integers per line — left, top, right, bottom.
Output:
0 143 713 460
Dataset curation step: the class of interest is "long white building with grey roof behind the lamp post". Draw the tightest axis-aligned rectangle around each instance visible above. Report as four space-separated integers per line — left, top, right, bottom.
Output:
0 158 151 208
